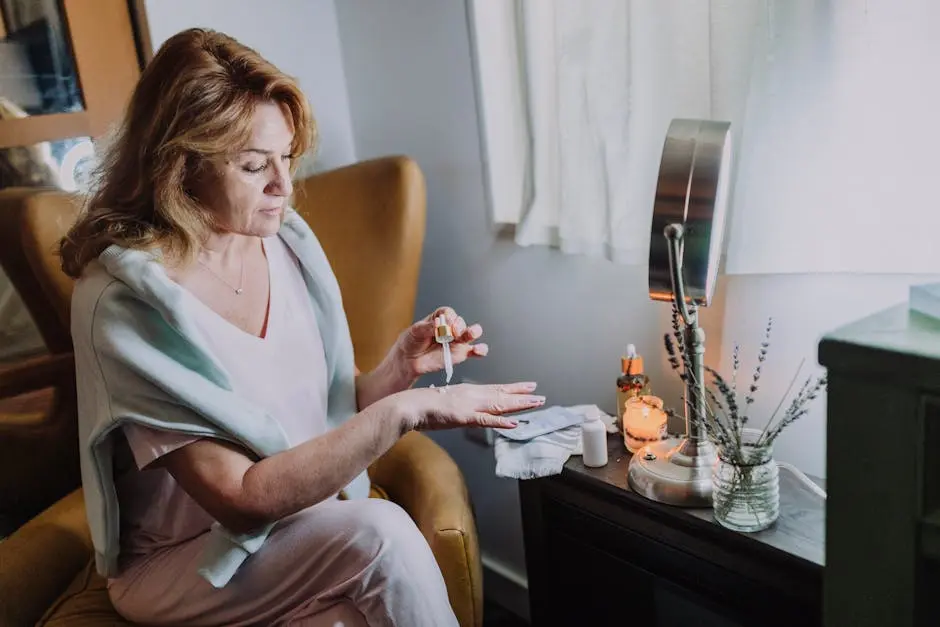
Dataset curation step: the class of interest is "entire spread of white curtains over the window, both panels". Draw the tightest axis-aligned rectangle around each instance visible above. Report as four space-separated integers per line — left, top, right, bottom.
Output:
471 0 940 274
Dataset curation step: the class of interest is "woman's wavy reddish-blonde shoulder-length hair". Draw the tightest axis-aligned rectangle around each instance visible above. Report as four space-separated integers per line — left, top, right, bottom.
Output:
59 28 316 278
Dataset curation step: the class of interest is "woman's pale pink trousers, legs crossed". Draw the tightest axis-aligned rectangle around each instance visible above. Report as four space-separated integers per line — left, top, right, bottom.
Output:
109 499 457 627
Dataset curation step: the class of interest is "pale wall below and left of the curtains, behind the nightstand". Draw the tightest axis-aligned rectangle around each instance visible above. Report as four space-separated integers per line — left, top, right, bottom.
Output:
337 0 929 600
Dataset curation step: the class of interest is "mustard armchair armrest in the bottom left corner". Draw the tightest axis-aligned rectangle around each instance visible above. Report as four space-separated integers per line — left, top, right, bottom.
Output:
0 489 93 626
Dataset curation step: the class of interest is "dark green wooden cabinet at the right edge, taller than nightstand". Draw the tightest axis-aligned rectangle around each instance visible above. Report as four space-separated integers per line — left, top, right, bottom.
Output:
819 304 940 627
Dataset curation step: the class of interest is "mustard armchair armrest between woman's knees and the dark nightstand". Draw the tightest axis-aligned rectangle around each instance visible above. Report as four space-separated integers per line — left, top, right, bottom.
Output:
369 433 483 627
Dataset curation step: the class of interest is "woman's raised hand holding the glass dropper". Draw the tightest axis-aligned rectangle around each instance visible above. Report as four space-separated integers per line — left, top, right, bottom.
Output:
393 307 489 380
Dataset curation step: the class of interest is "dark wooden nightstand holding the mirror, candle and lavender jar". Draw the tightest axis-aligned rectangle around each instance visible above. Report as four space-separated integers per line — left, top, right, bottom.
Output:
519 436 825 627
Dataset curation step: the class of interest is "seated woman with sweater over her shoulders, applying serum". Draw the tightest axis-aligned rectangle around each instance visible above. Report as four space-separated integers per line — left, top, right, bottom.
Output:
61 29 544 627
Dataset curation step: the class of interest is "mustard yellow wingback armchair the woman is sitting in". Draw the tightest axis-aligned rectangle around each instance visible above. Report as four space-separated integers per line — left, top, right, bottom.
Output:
0 157 483 627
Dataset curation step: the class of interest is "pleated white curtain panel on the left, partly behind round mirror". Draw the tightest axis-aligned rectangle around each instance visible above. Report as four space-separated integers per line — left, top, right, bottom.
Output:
471 0 767 263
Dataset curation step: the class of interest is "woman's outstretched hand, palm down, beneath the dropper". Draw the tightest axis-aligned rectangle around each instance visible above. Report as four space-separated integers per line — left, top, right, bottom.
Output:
385 383 545 431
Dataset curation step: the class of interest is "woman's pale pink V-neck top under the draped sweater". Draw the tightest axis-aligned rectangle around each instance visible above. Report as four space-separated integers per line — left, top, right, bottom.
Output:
115 236 327 569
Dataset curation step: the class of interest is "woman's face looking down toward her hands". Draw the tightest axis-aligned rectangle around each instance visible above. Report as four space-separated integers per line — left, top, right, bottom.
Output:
198 102 294 237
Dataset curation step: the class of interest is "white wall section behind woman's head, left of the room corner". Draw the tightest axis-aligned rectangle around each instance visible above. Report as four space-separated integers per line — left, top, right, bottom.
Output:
145 0 356 176
